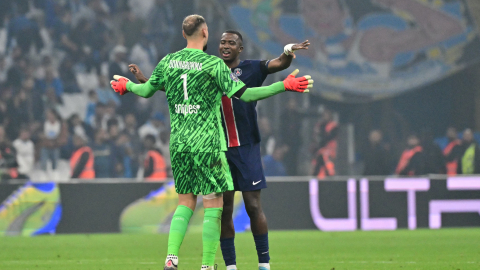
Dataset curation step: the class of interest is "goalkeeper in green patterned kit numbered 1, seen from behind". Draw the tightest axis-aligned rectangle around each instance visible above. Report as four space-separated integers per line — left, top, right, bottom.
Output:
111 15 313 270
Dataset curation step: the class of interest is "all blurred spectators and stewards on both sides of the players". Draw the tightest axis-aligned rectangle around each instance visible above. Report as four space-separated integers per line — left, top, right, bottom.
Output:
0 0 480 180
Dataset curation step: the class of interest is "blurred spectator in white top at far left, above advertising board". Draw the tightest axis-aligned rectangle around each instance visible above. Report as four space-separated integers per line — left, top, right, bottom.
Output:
13 128 35 179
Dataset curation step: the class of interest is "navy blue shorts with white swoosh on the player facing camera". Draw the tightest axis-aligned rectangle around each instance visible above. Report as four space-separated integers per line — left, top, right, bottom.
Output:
226 143 267 192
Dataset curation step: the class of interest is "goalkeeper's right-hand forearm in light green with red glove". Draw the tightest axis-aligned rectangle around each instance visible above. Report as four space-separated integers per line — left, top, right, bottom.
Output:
234 69 313 102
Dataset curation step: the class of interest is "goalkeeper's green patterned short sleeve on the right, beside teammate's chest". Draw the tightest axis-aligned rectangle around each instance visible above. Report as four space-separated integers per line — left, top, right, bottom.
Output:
212 58 246 98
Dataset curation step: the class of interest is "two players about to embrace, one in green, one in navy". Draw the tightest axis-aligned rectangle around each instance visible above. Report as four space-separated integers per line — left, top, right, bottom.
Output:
116 15 313 270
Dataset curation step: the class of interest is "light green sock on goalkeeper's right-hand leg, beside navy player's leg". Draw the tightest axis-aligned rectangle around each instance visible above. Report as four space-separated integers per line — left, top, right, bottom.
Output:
202 208 223 266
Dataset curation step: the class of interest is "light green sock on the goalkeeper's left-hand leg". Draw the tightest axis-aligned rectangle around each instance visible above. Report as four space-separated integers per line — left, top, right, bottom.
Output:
168 205 193 256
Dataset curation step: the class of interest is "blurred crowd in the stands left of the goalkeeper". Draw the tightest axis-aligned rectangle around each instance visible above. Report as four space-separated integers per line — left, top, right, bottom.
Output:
0 0 183 179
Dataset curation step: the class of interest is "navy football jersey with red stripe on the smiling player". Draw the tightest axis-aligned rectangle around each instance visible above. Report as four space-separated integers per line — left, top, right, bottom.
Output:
222 60 269 147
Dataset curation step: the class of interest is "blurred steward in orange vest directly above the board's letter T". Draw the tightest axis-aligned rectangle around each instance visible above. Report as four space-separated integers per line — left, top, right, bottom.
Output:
395 134 425 176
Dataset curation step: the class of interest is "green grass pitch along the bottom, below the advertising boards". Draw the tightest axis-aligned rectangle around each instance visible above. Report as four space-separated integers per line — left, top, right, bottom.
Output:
0 229 480 270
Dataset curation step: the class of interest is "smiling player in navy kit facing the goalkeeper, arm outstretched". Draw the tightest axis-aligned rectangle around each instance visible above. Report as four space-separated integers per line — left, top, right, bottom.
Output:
219 30 310 270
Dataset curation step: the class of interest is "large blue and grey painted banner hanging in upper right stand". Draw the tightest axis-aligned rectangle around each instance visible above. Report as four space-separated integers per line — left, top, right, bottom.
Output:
229 0 480 102
